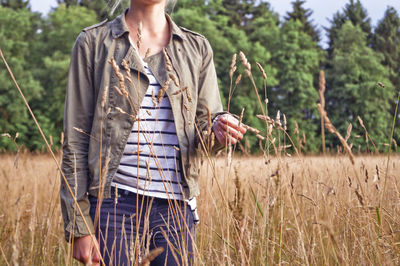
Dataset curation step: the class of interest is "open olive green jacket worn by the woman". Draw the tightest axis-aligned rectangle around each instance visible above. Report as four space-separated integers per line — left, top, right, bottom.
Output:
60 15 222 239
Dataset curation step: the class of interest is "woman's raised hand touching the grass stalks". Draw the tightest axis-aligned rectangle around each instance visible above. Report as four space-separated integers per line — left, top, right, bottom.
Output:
213 114 246 146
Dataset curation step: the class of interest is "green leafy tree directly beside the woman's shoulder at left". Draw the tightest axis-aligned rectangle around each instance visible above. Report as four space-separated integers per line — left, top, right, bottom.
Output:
28 4 97 148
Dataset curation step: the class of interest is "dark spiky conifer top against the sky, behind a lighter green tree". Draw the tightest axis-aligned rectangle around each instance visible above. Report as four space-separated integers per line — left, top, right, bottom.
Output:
285 0 321 43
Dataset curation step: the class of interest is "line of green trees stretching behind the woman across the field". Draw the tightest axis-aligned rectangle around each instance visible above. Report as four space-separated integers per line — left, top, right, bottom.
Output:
0 0 400 153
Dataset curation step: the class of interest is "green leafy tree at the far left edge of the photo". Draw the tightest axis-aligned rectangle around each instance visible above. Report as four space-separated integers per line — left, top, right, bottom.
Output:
0 6 42 149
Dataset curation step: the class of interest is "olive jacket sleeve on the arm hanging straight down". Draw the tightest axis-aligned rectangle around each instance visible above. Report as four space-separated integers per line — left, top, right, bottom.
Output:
60 32 95 241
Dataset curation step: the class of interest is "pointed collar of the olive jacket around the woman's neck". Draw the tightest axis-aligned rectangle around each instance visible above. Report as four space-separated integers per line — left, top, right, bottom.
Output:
111 9 186 40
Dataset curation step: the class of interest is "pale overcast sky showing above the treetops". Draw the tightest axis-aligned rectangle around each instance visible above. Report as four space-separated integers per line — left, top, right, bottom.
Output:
30 0 400 45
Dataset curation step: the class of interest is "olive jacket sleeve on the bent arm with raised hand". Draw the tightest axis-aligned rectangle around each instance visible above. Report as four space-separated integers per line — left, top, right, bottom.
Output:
196 38 226 151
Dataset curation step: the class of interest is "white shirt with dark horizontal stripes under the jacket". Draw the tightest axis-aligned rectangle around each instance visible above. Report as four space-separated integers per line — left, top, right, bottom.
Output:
112 42 199 223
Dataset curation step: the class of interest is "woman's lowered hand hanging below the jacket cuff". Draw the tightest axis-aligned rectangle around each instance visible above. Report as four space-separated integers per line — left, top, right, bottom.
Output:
72 235 100 266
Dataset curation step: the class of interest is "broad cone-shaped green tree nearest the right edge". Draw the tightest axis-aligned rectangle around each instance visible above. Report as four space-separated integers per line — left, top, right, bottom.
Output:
326 21 394 150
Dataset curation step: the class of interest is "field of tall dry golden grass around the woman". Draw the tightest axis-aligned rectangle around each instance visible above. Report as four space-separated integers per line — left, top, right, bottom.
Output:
0 154 400 265
